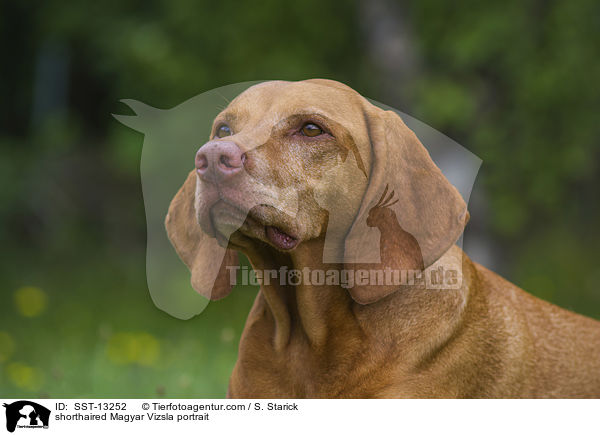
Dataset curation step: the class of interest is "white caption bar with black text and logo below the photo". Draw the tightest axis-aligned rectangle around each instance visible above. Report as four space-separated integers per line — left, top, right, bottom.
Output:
0 399 600 435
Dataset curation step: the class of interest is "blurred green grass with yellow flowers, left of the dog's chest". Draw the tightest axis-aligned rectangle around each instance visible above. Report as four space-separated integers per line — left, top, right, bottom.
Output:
0 247 256 398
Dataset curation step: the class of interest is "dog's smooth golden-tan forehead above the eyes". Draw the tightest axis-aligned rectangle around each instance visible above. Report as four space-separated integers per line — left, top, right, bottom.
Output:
222 81 370 134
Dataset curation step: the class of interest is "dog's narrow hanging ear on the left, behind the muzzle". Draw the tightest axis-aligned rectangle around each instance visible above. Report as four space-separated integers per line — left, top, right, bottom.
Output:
165 171 238 300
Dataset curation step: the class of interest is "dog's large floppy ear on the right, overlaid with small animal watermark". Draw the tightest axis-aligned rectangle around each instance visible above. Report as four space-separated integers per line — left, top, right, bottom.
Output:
344 106 469 304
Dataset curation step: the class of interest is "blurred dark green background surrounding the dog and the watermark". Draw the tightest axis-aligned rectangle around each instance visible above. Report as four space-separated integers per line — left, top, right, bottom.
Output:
0 0 600 398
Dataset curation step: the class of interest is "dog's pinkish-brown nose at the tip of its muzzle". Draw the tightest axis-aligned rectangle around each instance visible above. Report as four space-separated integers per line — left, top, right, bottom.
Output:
196 141 246 182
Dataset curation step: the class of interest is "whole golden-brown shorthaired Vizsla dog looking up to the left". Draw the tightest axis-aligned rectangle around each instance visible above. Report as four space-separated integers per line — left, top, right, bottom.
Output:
166 80 600 398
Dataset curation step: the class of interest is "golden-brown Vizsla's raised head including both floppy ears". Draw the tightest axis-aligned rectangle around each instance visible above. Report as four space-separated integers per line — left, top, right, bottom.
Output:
166 80 468 303
